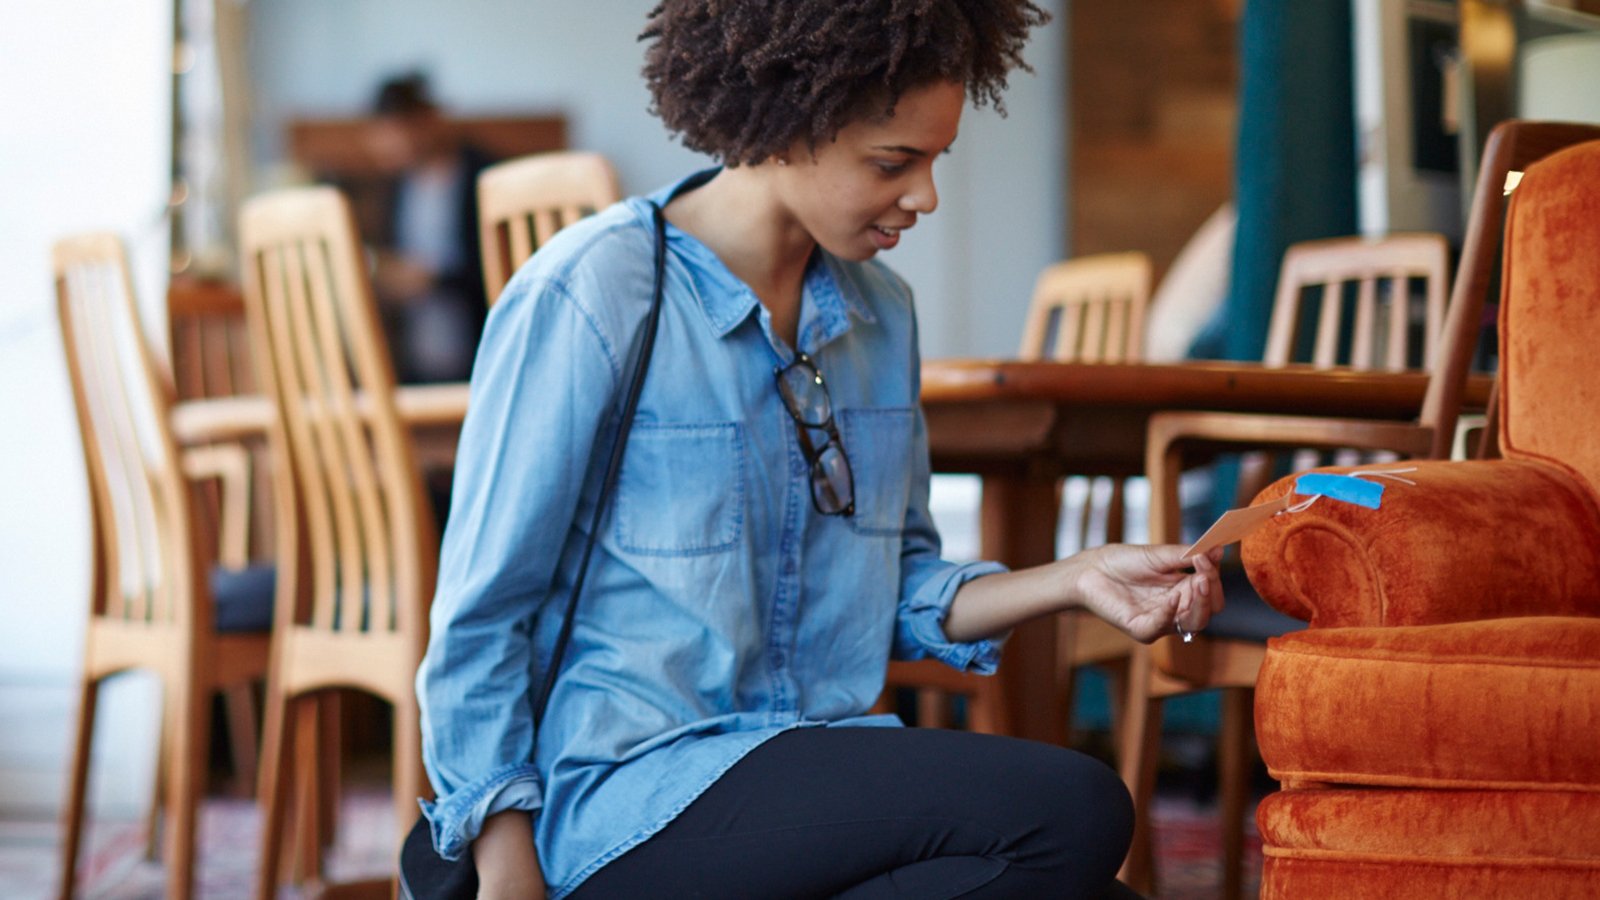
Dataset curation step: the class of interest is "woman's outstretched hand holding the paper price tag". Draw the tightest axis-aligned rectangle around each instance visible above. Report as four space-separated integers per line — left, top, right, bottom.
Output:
1070 544 1222 644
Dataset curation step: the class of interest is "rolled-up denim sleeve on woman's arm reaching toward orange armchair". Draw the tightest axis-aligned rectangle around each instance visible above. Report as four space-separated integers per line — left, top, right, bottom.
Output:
893 400 1006 674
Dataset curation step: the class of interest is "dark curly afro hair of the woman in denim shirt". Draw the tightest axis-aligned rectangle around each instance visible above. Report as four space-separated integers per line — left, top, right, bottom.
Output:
640 0 1050 167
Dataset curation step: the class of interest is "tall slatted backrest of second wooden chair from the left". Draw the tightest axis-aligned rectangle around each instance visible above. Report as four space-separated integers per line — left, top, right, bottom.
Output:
242 187 437 634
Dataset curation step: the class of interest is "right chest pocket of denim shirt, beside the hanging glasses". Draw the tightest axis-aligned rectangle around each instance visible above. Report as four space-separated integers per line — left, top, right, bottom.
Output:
838 408 917 536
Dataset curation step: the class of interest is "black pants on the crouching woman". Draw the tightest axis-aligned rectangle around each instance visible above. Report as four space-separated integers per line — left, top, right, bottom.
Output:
573 729 1133 900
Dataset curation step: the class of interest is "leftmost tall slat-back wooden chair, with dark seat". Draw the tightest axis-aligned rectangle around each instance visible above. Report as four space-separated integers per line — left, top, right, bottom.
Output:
53 234 272 897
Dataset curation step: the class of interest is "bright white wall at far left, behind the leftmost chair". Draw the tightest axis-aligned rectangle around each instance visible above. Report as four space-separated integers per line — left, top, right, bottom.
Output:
0 0 171 812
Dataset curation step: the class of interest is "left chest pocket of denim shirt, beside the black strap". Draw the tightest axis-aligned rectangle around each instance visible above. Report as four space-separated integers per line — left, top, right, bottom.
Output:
614 423 744 556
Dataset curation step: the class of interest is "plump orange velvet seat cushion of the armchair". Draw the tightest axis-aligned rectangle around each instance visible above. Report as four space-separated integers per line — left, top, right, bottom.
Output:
1256 617 1600 791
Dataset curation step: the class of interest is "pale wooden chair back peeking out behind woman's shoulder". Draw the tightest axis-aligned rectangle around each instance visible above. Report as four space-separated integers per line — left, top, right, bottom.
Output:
478 151 622 304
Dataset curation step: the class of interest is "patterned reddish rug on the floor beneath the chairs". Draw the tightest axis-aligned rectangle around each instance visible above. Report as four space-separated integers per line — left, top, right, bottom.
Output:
0 790 1261 900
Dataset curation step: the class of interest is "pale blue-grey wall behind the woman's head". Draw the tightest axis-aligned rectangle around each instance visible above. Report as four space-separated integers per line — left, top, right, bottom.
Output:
250 0 1066 357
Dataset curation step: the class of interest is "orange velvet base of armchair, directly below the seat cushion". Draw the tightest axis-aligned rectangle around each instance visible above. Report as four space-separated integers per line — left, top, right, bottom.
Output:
1256 790 1600 898
